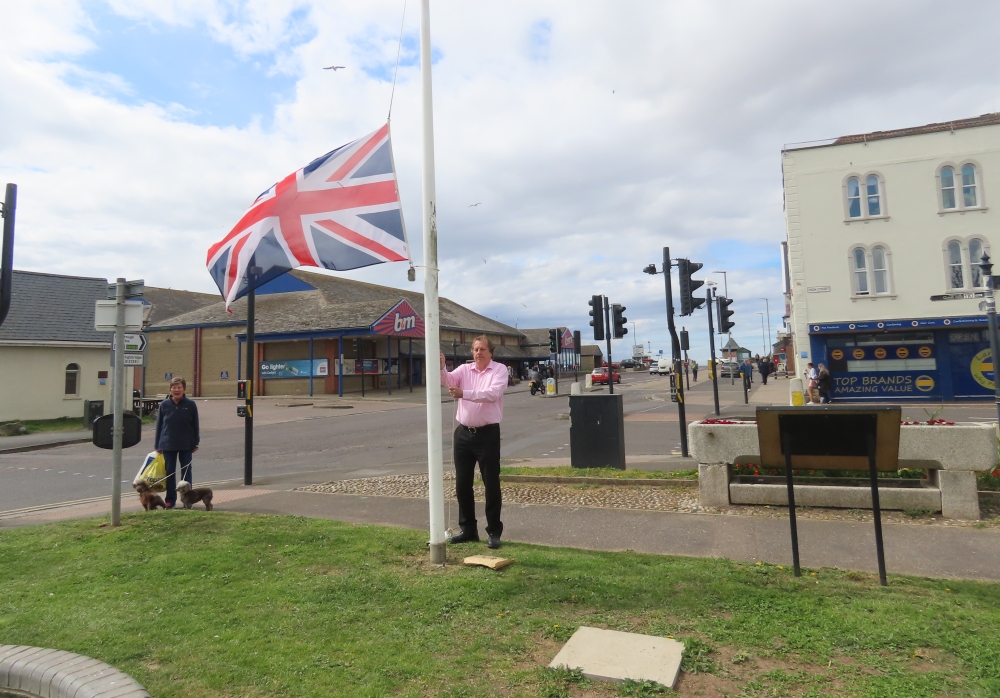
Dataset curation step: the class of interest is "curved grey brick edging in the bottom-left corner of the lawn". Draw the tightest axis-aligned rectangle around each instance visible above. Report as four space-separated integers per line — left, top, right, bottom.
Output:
0 645 151 698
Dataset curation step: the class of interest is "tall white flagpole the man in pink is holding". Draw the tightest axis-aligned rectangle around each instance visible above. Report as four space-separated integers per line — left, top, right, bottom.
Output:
420 0 445 565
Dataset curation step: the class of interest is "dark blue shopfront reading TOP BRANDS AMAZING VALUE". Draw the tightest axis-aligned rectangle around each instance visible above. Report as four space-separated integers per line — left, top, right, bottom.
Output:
803 315 993 402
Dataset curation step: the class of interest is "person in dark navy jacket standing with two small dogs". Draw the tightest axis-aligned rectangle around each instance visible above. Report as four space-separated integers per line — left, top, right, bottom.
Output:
153 376 201 509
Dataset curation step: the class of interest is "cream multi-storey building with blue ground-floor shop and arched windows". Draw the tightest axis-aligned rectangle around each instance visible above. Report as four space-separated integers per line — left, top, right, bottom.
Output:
782 114 1000 400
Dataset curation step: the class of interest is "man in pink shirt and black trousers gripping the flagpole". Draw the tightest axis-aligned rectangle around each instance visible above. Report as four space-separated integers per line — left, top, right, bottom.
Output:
441 335 508 549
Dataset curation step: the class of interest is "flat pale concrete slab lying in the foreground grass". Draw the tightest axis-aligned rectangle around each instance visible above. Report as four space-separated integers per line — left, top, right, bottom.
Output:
549 625 684 688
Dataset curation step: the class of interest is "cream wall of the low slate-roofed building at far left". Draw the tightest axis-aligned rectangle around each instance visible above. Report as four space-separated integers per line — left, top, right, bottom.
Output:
0 342 122 421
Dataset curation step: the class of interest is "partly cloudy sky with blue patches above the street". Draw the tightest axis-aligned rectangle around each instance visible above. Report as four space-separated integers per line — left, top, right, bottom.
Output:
0 0 1000 363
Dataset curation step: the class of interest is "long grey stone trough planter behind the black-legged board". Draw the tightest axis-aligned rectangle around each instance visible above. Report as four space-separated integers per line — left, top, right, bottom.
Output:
688 422 997 520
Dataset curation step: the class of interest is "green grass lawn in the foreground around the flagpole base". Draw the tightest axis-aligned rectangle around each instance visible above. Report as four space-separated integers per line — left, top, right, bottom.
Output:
0 511 1000 698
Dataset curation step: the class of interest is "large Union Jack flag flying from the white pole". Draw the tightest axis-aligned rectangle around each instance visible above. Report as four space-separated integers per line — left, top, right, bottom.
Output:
207 124 410 308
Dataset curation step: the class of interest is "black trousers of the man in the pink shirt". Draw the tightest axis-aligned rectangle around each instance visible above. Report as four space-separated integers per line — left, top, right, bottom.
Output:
454 424 503 536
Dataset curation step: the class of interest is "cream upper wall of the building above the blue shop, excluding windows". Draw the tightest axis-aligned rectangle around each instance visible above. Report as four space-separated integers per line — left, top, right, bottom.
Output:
782 125 1000 365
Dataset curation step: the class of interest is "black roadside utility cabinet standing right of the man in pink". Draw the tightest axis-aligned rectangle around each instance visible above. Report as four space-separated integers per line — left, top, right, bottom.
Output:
569 393 625 470
